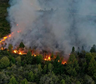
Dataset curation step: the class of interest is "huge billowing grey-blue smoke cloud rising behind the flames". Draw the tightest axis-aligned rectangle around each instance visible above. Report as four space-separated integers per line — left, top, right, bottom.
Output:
7 0 96 54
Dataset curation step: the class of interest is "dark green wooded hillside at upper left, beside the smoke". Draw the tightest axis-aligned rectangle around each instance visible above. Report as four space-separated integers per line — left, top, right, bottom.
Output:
0 0 10 38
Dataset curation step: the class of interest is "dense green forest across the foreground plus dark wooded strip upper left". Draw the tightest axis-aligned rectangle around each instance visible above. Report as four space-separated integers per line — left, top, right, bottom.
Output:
0 0 96 84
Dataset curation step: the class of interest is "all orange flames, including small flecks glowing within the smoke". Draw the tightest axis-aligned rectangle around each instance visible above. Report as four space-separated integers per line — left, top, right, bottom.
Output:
0 31 67 65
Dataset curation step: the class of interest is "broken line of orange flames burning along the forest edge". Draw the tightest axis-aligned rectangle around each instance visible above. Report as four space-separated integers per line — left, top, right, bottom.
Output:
0 31 67 65
